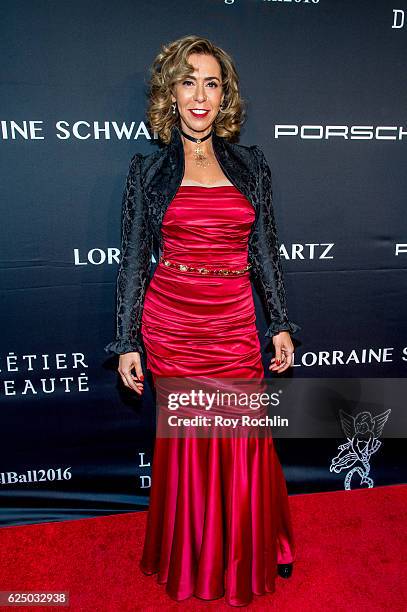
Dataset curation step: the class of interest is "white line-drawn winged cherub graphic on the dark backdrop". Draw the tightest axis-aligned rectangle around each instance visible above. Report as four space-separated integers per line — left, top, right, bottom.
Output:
329 408 391 490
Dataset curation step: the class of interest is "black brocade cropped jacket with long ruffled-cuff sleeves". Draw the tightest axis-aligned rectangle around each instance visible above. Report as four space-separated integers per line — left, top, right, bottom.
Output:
104 127 301 354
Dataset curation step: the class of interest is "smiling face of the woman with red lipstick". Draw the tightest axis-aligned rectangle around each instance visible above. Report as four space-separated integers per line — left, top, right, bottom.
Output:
171 53 223 138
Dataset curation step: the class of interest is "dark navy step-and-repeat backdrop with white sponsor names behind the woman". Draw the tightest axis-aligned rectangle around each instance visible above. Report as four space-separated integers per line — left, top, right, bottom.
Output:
0 0 407 524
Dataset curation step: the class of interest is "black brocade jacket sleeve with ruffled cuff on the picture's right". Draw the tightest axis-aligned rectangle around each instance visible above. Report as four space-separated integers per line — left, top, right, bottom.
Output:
251 145 302 337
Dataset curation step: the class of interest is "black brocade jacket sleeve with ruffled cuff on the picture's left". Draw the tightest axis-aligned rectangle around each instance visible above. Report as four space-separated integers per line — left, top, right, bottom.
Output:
104 153 152 355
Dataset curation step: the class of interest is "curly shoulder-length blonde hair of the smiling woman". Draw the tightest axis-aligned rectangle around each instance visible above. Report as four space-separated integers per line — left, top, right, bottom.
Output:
147 35 246 144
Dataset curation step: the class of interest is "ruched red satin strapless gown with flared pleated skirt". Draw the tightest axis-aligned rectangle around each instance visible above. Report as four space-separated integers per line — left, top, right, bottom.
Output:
140 185 295 606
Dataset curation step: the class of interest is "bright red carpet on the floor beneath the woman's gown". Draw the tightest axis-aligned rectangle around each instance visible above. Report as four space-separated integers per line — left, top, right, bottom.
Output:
0 485 407 612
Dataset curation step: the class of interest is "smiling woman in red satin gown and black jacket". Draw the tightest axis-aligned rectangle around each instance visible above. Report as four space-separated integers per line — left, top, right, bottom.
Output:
105 36 301 606
